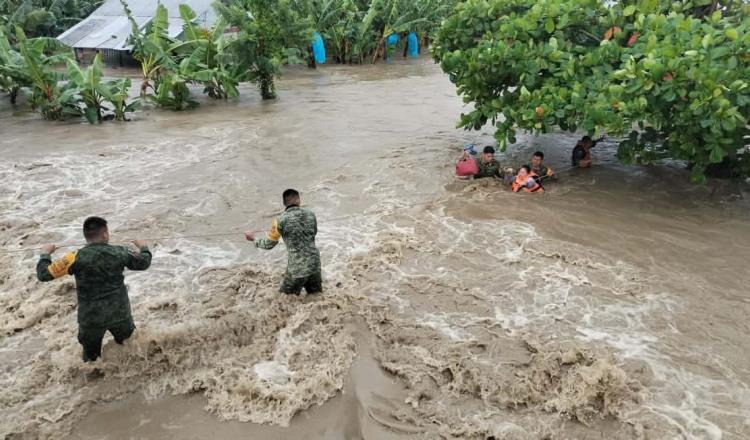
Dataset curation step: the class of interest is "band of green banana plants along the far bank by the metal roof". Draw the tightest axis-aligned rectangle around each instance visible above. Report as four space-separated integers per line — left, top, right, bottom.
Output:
0 0 453 117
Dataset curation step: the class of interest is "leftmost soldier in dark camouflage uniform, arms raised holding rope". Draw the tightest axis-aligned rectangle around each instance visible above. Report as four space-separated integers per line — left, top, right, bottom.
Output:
36 217 151 362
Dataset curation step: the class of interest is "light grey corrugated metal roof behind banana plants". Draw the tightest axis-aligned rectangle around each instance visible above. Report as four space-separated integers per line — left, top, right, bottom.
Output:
57 0 216 50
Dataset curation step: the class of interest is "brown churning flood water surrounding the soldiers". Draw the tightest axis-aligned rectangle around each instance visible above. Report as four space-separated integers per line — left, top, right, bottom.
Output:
0 60 750 439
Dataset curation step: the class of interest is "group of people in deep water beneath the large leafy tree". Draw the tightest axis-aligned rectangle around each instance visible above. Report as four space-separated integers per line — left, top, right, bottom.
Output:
456 136 604 193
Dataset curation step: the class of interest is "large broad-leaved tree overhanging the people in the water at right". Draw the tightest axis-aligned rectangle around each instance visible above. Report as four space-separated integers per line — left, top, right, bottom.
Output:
433 0 750 181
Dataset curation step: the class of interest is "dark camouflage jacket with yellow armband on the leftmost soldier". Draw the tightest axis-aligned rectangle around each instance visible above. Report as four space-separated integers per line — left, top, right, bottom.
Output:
36 243 151 327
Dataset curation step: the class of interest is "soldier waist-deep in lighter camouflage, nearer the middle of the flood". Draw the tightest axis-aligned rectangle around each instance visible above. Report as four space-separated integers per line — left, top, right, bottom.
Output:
245 189 323 295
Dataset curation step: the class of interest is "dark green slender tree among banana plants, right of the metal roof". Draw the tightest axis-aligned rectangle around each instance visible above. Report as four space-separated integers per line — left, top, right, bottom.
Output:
217 0 312 99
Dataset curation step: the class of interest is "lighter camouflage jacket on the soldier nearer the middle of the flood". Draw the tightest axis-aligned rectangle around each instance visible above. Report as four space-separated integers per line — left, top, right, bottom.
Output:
255 206 320 278
